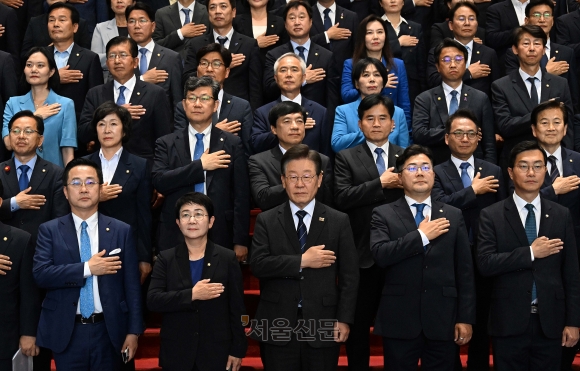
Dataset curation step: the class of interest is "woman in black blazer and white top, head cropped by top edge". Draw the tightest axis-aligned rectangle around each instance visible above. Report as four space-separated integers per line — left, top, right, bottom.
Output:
234 0 289 65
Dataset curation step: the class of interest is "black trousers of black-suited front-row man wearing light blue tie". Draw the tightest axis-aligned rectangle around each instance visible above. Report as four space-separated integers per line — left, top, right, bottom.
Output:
383 333 457 371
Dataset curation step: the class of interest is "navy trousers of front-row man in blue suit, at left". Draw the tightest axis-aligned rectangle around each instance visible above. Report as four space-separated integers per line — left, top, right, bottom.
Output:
53 321 122 371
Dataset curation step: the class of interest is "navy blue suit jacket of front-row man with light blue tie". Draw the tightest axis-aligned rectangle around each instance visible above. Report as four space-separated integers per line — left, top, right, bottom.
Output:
33 213 143 353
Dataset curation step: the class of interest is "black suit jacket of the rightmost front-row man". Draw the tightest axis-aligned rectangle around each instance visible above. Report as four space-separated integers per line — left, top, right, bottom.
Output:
477 197 580 339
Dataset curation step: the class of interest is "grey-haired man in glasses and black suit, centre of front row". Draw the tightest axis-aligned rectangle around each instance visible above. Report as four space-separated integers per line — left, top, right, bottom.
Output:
250 144 359 371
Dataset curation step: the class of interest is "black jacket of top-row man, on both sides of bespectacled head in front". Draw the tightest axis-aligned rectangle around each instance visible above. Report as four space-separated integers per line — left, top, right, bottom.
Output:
427 42 502 97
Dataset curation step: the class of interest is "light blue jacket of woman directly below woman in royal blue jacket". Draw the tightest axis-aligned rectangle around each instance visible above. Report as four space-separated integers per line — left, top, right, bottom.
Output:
330 98 409 153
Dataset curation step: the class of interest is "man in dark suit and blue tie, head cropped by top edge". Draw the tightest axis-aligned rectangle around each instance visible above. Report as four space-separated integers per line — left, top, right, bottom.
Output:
153 0 209 59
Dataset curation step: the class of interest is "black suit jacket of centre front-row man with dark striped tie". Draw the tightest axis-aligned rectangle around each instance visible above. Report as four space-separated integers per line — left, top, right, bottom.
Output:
250 202 359 348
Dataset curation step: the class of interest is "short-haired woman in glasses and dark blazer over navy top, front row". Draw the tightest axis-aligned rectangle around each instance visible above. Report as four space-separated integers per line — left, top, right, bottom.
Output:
147 192 248 371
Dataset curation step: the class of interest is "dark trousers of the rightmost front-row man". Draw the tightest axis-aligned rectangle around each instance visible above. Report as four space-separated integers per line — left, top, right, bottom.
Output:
492 314 562 371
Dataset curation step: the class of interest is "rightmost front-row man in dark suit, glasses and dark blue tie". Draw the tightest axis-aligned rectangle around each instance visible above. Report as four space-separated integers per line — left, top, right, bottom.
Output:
477 141 580 371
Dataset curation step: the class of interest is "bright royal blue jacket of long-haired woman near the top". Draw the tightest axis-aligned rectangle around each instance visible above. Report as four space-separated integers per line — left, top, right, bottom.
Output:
340 58 411 128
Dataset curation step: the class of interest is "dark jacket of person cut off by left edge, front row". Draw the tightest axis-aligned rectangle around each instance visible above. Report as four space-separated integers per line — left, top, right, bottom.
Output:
0 224 39 361
